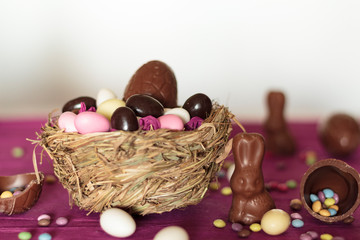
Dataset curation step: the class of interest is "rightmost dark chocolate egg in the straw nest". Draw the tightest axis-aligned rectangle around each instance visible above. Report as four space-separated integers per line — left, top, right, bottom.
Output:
183 93 212 119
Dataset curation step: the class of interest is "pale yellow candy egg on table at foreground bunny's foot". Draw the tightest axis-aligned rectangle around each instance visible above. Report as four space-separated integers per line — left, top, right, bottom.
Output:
261 209 291 235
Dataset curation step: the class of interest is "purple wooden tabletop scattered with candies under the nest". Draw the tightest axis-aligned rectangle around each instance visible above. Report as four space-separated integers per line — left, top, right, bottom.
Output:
0 118 360 240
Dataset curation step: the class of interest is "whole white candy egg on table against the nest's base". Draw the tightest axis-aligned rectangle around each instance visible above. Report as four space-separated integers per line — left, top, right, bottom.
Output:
100 208 136 238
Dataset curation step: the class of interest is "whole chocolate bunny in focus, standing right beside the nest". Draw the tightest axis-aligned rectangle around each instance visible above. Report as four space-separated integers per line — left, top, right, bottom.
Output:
229 133 275 225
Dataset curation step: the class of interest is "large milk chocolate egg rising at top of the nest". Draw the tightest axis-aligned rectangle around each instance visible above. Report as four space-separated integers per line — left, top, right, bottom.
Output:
124 61 177 108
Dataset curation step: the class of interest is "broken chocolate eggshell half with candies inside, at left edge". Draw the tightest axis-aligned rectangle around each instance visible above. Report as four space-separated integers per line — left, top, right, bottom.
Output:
0 172 44 215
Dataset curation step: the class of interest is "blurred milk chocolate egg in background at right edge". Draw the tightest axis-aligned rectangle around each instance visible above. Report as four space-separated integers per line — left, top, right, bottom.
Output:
319 113 360 156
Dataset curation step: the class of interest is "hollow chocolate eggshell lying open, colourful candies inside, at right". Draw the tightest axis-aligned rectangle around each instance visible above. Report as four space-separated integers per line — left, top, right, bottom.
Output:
300 159 360 223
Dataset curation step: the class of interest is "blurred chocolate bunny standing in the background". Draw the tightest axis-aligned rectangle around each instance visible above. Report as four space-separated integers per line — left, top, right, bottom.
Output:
264 91 296 155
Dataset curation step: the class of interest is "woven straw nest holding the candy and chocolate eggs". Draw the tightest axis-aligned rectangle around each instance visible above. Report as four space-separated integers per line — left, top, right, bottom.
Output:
34 104 233 215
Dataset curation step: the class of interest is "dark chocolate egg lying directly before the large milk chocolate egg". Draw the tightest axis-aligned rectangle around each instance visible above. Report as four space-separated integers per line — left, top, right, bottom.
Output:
126 94 164 118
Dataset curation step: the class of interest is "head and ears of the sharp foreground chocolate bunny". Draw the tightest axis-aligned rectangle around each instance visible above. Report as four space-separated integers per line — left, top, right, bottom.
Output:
230 133 265 197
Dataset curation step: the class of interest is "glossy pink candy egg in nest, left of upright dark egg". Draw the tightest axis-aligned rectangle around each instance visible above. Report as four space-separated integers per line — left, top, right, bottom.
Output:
75 112 110 134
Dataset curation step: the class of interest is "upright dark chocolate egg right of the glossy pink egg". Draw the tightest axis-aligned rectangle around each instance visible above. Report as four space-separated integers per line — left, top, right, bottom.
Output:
111 107 139 131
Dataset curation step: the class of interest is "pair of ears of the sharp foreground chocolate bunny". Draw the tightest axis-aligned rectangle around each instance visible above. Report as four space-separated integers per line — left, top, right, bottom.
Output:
232 133 265 169
